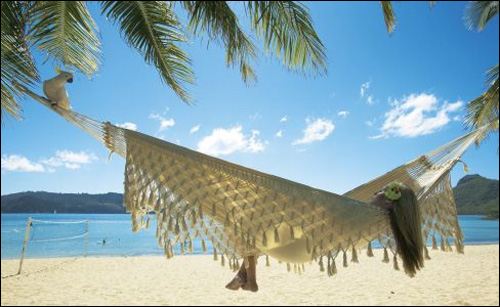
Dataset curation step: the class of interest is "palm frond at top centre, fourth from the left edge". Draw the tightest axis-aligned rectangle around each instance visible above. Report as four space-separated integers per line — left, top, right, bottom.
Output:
182 1 256 83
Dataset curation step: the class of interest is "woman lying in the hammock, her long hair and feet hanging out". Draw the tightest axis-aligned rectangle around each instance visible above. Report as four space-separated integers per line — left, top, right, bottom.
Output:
226 183 424 292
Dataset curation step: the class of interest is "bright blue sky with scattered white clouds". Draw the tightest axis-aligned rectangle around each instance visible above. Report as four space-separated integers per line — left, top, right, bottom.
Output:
1 2 499 195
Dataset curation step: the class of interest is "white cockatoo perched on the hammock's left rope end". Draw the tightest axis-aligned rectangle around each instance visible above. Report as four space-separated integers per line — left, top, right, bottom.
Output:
43 67 73 110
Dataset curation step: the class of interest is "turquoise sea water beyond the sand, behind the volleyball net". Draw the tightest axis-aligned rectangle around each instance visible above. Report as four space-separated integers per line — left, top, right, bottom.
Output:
1 214 499 259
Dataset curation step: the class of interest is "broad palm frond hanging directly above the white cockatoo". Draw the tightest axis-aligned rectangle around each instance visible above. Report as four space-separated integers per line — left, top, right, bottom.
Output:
30 1 100 76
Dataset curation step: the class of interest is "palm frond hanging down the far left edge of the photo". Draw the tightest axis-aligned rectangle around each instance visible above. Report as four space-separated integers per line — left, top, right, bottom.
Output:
1 1 39 122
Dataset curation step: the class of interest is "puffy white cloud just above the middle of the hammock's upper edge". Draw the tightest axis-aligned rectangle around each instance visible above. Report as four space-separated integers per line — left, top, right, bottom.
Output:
198 125 265 156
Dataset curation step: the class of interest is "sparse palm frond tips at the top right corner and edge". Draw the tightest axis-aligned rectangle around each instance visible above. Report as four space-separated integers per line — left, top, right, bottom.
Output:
380 1 498 145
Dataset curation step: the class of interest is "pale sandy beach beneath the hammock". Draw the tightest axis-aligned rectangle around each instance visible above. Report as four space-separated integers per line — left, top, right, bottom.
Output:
1 245 499 306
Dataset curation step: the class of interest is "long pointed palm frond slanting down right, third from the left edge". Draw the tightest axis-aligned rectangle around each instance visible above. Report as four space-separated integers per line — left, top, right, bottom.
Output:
102 1 194 103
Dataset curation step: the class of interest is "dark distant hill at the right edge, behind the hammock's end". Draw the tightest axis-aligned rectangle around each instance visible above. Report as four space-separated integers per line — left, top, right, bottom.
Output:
453 175 498 219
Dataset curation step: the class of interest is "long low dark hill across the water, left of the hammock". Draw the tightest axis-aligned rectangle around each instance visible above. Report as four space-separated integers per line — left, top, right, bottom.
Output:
1 192 125 213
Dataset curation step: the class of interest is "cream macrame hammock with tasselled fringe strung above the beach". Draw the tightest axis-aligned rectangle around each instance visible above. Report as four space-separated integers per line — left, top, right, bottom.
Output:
20 89 484 276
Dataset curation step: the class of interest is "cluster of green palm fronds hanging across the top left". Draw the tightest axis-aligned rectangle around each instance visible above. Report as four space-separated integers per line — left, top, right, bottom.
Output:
1 1 326 121
